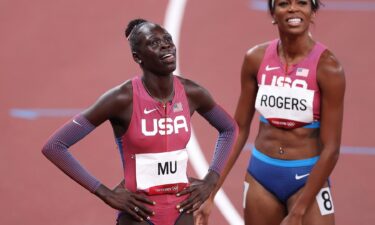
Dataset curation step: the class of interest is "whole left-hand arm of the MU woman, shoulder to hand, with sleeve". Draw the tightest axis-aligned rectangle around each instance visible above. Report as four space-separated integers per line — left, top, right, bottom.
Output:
42 83 153 221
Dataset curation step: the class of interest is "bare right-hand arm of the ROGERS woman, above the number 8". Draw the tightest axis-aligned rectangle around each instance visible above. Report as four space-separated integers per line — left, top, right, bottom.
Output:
284 51 345 220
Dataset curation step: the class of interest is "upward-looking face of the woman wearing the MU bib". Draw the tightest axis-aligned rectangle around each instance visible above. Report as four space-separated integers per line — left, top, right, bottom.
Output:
136 23 176 75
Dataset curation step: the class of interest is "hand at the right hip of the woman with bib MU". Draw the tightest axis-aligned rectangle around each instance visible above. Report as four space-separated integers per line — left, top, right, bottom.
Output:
177 170 219 213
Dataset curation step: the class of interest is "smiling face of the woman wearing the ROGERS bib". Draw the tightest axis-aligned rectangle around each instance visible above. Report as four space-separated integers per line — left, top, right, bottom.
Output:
272 0 315 34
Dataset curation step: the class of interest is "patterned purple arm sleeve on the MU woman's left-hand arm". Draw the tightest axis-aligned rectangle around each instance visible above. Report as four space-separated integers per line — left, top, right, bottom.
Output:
42 114 101 193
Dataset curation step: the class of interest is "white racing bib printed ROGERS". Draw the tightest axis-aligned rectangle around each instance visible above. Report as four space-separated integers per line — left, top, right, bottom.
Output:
255 85 314 127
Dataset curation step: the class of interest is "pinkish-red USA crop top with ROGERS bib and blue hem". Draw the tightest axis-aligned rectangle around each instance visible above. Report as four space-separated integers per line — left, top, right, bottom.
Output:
255 39 326 129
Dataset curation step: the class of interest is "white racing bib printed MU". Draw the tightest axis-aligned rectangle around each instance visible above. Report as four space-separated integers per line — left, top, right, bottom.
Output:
135 149 188 195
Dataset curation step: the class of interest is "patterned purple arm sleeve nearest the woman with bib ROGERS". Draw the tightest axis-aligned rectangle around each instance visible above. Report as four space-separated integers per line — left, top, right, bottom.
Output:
202 105 238 174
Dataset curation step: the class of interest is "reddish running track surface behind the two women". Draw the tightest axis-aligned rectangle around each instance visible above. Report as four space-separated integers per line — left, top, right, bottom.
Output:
0 0 375 225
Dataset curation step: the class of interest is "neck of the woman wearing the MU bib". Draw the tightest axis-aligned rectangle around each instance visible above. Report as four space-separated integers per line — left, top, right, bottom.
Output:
141 74 174 103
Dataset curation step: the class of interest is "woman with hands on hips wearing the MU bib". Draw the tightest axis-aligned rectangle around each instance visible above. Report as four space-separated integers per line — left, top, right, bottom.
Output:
42 19 238 225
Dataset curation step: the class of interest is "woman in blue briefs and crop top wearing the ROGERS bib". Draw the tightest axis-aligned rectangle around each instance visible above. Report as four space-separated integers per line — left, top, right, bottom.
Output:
196 0 345 225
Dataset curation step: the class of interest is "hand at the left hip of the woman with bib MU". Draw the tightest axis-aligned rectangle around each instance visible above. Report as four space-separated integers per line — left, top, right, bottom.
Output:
95 181 155 221
